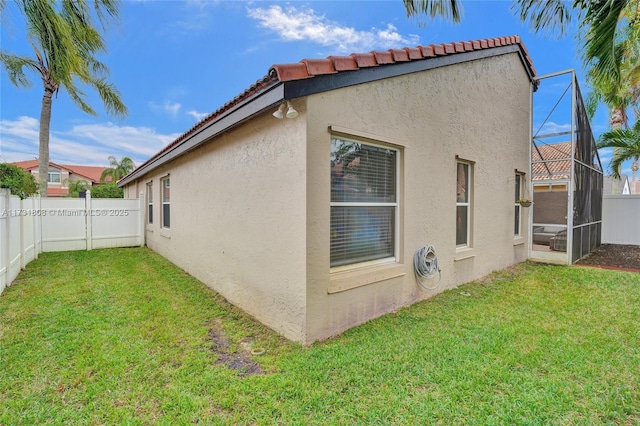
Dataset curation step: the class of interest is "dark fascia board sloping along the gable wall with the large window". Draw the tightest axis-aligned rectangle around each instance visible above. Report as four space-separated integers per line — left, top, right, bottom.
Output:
284 44 533 99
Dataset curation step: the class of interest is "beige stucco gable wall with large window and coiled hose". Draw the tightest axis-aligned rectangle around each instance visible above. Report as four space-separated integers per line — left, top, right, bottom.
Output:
305 54 531 343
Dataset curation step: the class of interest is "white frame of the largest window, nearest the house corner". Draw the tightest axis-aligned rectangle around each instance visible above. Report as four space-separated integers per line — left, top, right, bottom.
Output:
329 133 402 273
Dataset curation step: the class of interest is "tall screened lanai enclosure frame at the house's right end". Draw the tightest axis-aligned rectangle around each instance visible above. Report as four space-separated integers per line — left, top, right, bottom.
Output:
529 69 604 264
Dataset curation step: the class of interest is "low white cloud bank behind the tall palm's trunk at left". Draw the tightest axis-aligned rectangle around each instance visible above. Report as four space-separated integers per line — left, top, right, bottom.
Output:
0 117 179 166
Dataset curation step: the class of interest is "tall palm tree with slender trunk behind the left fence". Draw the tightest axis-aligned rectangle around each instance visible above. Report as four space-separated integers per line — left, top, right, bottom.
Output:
0 0 127 196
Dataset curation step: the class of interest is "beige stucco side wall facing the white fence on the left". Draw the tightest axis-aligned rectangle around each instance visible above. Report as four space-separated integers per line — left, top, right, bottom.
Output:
127 111 306 341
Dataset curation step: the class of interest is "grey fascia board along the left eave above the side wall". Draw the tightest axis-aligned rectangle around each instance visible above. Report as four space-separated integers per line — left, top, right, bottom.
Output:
118 83 284 187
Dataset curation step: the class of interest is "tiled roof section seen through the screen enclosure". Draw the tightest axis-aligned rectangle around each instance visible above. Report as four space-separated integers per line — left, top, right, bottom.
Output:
531 142 571 181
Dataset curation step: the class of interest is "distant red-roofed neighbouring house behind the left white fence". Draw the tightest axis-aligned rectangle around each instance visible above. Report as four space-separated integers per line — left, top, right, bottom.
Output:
12 159 110 197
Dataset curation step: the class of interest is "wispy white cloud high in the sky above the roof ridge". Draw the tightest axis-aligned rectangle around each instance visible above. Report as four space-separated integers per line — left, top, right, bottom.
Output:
248 5 420 52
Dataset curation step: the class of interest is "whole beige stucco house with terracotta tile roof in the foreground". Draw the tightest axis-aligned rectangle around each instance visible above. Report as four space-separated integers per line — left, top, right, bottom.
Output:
119 36 536 344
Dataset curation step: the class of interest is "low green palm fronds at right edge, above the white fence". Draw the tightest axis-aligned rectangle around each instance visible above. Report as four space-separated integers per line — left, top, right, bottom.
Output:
597 120 640 188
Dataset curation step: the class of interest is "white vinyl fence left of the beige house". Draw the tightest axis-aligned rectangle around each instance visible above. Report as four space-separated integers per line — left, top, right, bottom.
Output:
0 189 144 294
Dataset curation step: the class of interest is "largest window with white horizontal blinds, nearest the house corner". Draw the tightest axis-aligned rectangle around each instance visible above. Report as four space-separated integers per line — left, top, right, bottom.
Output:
331 137 399 267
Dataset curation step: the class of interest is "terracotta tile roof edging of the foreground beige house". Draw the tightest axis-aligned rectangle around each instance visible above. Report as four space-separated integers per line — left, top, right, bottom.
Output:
123 35 536 185
